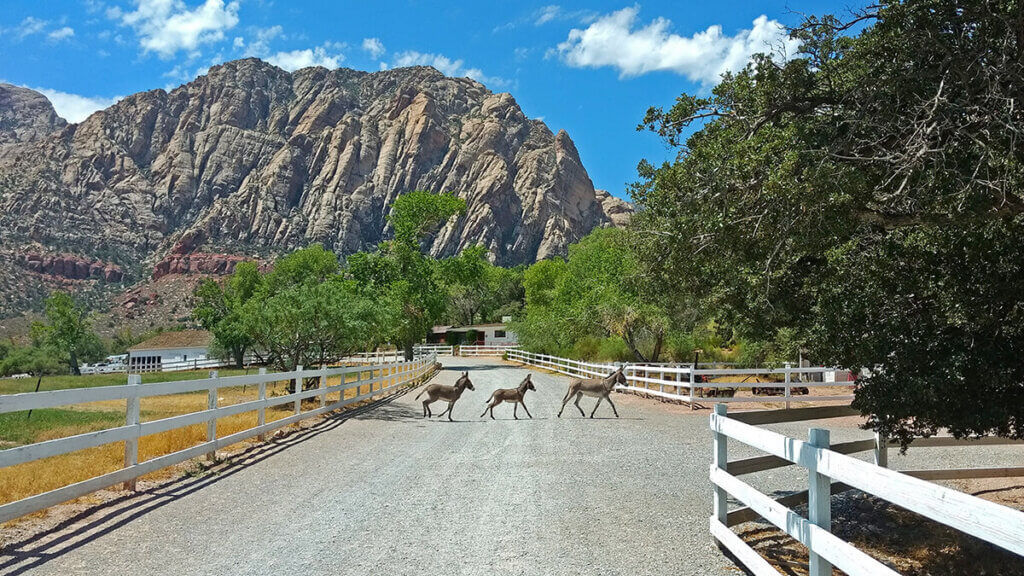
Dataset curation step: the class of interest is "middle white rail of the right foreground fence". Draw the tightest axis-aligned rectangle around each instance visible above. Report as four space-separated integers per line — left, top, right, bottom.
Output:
711 466 899 576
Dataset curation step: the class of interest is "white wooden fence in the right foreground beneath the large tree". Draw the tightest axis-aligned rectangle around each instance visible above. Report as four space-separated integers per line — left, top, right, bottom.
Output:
711 404 1024 576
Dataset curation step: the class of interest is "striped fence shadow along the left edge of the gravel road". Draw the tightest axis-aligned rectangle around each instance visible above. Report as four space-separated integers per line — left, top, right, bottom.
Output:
0 388 412 576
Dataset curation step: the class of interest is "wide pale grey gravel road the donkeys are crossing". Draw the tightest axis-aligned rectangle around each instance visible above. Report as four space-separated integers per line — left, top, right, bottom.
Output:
0 358 1007 576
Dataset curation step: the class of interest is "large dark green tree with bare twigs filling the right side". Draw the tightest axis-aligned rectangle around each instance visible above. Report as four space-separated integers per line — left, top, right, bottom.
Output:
634 0 1024 442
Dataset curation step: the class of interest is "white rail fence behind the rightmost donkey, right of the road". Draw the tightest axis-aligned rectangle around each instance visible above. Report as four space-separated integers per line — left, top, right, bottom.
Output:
506 349 853 408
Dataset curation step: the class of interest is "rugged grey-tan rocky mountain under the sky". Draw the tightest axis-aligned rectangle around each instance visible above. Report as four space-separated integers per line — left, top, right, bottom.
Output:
0 58 632 313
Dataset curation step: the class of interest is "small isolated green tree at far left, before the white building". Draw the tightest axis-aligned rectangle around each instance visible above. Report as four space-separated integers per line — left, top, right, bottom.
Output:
32 292 104 376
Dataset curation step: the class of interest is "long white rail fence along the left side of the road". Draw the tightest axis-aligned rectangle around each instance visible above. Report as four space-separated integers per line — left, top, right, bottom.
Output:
0 355 436 523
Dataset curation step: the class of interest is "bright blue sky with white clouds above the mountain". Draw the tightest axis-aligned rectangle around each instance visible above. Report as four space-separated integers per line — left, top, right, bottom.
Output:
0 0 856 197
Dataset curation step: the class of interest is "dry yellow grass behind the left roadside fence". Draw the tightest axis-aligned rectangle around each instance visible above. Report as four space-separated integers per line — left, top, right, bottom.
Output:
0 370 411 504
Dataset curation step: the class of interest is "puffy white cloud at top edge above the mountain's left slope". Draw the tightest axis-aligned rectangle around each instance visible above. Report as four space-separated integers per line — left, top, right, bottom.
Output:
117 0 239 58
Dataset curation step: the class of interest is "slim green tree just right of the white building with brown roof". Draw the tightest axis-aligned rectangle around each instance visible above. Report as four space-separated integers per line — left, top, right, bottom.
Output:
193 262 260 367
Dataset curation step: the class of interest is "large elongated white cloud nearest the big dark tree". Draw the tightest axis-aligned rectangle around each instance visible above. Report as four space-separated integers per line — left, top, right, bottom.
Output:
556 6 799 86
